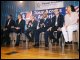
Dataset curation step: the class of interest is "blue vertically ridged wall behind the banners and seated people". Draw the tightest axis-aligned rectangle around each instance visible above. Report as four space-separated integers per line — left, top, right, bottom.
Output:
1 1 79 26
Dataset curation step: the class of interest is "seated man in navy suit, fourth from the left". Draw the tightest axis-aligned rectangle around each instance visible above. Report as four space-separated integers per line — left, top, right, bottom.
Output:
34 12 51 47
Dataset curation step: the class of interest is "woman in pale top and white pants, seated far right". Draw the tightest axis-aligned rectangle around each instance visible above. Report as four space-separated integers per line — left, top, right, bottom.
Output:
62 5 79 42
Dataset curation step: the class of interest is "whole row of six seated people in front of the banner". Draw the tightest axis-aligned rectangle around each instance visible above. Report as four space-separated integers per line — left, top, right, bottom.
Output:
1 5 78 48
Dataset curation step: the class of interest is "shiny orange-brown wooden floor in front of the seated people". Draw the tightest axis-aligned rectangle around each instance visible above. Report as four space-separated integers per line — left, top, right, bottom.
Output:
1 42 79 59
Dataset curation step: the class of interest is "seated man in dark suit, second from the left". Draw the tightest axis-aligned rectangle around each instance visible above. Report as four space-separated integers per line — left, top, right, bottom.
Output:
15 14 25 46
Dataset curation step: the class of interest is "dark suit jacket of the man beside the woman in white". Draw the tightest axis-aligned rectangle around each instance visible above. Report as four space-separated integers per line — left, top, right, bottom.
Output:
51 14 64 27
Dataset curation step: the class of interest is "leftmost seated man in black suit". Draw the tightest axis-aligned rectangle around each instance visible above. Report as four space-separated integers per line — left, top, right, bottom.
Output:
4 15 15 45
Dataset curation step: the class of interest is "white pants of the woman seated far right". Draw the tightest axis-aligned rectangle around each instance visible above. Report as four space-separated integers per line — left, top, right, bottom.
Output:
61 24 79 42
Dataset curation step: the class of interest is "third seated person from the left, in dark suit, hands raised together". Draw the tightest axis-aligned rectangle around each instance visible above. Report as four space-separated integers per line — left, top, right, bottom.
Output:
26 16 38 41
